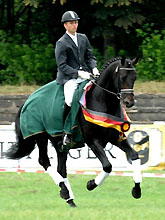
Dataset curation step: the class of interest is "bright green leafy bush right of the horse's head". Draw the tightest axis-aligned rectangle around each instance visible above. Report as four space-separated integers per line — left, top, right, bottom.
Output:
137 27 165 81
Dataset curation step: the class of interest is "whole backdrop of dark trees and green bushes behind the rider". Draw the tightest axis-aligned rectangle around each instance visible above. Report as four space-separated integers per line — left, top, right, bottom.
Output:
0 0 165 85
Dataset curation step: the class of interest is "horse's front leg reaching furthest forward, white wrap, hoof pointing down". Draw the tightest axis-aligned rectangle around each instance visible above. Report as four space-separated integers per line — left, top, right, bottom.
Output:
117 139 142 199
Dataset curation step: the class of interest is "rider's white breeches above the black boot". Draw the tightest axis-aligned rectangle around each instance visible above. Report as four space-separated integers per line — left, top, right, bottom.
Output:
64 78 84 106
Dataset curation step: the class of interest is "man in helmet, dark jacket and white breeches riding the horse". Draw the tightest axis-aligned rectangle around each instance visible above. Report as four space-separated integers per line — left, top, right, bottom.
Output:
55 11 99 145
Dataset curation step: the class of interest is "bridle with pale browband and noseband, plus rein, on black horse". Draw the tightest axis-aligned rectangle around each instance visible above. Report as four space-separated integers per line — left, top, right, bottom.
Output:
91 66 136 99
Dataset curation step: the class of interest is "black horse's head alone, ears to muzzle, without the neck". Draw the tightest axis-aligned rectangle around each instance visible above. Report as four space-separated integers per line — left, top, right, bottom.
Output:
118 56 139 108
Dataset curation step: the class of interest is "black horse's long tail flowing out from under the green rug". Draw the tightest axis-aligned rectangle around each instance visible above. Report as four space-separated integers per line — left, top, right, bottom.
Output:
5 106 35 159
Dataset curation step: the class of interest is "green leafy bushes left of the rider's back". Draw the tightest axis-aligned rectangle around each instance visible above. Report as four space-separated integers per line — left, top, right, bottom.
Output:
0 32 56 85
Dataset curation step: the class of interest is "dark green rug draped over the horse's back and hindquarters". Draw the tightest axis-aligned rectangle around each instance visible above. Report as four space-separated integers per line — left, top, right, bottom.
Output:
20 81 87 147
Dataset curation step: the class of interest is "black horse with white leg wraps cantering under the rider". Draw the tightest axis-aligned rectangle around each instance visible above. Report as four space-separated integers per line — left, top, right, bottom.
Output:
6 57 142 207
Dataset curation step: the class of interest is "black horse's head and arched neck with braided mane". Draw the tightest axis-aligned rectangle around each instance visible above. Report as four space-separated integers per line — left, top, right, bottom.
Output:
93 56 139 108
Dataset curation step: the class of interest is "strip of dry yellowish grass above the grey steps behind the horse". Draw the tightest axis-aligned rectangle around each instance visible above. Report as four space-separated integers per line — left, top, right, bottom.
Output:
0 80 165 95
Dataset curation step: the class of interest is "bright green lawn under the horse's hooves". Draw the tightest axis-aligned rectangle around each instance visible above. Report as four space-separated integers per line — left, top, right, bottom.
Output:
0 173 165 220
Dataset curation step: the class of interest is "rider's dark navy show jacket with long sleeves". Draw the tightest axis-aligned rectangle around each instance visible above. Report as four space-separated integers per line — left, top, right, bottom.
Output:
55 33 97 84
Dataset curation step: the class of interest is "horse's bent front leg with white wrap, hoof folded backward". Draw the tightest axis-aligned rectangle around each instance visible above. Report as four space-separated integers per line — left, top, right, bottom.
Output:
87 140 112 190
